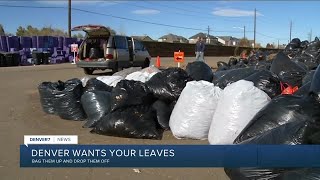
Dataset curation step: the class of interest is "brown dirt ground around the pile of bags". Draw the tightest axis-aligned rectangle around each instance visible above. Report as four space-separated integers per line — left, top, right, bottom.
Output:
0 57 228 180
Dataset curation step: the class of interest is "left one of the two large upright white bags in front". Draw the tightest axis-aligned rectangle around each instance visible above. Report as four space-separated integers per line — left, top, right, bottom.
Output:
169 81 222 140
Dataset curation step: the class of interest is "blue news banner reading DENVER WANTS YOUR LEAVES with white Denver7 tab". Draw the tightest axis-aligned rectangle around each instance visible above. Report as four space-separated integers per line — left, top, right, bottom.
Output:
20 135 320 168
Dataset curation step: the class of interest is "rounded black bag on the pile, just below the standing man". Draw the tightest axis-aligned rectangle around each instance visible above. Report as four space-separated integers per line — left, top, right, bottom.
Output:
186 61 213 82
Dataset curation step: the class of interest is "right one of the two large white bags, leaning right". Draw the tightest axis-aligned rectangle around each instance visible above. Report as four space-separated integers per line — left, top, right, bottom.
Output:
208 80 271 144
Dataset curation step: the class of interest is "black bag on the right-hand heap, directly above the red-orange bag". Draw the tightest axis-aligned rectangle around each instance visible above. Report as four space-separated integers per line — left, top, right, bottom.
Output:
270 52 306 76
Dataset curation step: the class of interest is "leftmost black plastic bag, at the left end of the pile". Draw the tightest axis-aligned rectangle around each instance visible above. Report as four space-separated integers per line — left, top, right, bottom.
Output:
38 81 64 114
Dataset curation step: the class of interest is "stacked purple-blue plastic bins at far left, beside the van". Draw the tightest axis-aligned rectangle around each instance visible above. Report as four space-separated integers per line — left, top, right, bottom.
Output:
0 36 82 65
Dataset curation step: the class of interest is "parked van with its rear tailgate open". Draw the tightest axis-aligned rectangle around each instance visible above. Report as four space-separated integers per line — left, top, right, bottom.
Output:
72 25 151 74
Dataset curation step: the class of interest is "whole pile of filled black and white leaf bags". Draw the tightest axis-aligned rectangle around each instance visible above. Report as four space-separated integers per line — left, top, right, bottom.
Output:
38 38 320 179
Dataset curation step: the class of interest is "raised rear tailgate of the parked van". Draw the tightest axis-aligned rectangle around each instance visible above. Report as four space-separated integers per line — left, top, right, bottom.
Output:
71 24 111 37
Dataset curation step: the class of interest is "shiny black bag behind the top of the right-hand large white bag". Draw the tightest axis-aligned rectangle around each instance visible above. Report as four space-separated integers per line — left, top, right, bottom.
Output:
244 70 281 98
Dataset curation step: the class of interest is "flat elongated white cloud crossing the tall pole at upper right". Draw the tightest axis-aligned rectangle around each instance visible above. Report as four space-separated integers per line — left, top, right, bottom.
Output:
212 8 262 17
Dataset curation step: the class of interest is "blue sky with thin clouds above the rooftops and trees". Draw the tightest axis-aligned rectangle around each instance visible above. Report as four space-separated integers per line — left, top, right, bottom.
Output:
0 0 320 45
